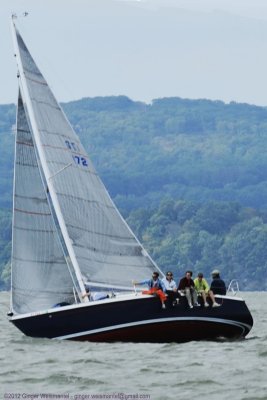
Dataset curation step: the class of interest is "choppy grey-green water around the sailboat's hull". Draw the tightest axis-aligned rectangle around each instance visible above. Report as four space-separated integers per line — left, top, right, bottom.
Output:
0 292 267 400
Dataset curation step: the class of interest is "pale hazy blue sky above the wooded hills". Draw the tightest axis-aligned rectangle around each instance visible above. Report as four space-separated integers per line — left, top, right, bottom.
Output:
0 0 267 106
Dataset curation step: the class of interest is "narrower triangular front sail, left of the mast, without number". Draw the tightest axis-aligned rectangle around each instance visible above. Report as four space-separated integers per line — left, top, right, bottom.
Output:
12 94 74 313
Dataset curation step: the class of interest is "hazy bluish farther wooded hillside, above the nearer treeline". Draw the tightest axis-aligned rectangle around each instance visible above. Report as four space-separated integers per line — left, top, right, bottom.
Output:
0 96 267 211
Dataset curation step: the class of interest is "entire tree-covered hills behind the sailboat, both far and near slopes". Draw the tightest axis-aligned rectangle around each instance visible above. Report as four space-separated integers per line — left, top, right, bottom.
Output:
0 96 267 290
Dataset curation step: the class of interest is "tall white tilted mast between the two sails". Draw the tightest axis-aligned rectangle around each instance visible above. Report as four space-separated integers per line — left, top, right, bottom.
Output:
11 16 89 302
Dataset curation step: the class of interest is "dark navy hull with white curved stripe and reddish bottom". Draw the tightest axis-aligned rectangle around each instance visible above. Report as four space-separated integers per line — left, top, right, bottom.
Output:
10 296 253 343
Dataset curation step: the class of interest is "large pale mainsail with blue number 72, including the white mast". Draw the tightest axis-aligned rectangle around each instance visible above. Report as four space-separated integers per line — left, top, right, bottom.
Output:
12 21 161 312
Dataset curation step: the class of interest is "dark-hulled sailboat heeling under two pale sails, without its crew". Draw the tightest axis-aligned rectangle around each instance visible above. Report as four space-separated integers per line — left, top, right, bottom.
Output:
8 19 253 342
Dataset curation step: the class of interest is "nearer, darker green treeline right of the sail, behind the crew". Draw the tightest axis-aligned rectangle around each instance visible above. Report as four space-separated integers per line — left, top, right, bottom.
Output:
127 200 267 290
